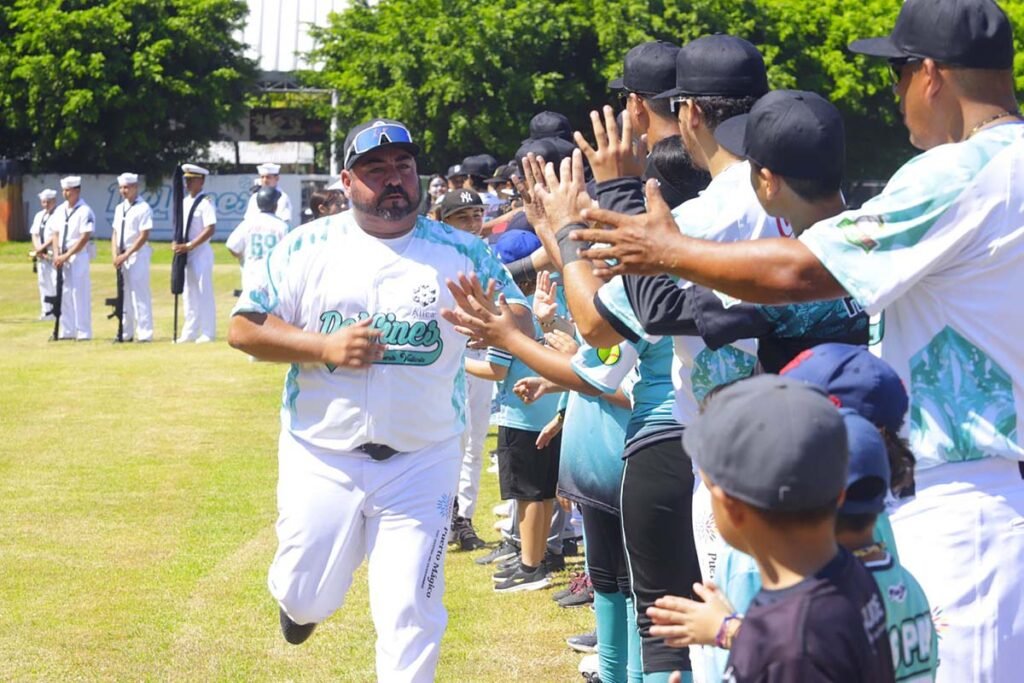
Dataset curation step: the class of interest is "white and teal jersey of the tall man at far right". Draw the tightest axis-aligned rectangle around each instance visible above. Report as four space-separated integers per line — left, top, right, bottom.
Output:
800 124 1024 469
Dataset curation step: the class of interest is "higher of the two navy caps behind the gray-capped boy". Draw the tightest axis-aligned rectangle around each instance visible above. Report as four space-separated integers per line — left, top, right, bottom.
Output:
779 343 910 434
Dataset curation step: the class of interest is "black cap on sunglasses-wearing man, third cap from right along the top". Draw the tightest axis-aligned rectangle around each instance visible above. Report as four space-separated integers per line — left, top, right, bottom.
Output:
655 34 768 99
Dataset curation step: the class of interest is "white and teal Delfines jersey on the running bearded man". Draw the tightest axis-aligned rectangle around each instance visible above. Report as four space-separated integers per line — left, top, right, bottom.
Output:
232 212 525 452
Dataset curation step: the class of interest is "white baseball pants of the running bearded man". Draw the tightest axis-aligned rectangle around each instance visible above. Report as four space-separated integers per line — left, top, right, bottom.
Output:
267 432 461 683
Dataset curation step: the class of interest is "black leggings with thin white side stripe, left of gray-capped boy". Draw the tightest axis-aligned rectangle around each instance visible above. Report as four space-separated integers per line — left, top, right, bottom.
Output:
614 436 700 674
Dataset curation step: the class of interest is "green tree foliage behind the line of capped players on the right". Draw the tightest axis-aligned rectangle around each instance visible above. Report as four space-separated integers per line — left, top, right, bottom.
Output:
306 0 1024 178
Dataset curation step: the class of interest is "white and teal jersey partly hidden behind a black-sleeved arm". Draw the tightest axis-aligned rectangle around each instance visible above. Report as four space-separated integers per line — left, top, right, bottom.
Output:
598 162 791 425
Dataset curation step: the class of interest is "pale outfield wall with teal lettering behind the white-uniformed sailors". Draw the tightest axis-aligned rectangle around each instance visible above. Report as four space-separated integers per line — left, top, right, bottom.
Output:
22 173 302 242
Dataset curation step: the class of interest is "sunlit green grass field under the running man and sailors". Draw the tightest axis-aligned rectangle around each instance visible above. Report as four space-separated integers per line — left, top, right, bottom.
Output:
0 244 593 682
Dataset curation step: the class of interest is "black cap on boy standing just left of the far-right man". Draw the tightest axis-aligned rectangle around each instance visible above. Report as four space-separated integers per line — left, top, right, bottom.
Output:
715 90 846 187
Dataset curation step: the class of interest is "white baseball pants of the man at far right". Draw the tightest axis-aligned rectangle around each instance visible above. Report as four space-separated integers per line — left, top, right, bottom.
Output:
892 458 1024 683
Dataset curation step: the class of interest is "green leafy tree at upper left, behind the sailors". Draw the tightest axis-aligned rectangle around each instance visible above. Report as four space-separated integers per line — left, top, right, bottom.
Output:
0 0 256 173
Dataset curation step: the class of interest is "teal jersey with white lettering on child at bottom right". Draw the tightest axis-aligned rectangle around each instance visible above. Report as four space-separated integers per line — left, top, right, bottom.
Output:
864 553 939 681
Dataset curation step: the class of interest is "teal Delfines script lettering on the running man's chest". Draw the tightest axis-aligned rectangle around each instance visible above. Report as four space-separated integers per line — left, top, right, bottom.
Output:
319 310 444 373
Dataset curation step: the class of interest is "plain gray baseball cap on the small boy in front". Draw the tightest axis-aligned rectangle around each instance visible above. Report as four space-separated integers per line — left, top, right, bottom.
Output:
683 375 849 512
